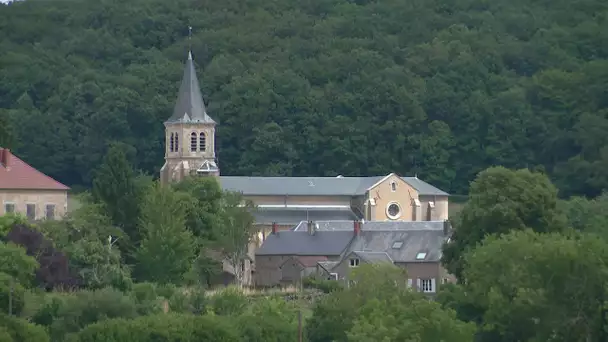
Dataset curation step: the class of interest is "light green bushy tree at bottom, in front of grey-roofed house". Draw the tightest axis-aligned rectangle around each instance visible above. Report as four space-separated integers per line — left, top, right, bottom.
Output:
306 264 475 342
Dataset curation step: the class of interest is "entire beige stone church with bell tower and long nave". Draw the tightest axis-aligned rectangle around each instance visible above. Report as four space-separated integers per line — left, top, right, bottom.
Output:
160 52 449 239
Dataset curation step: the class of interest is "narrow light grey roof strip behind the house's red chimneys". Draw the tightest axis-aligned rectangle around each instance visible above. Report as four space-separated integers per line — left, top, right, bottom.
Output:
293 220 444 231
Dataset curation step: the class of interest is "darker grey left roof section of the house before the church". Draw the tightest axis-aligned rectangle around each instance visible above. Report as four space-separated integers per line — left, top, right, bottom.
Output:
255 230 354 256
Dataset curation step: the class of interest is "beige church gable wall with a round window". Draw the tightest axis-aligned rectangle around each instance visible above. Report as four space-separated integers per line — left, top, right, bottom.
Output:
368 174 419 221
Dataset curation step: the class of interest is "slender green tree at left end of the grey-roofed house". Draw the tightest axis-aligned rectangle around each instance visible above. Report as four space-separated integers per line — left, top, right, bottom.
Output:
214 192 256 286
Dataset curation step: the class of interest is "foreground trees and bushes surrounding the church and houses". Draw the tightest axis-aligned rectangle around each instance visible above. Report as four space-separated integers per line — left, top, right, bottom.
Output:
0 145 608 342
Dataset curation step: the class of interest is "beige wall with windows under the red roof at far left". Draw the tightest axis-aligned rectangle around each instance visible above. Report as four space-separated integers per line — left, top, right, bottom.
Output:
0 190 68 220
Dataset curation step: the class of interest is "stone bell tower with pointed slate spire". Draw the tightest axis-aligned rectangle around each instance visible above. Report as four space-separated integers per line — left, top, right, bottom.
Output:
160 51 220 184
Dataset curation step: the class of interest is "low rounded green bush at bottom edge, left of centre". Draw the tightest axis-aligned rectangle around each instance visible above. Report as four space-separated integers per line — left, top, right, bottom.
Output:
71 314 241 342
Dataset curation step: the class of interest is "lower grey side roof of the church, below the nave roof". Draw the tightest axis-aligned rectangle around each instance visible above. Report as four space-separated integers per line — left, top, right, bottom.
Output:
253 208 359 226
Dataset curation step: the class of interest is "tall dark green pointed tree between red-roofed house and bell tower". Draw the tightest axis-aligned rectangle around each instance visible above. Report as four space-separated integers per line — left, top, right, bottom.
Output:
92 144 145 254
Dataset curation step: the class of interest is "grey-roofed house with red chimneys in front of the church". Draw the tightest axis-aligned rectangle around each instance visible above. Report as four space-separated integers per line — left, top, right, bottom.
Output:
255 221 455 293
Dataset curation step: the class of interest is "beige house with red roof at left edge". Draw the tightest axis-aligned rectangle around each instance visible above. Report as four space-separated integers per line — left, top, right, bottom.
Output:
0 147 69 220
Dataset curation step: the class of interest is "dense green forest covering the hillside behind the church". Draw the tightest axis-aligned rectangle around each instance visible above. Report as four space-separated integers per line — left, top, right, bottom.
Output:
0 0 608 196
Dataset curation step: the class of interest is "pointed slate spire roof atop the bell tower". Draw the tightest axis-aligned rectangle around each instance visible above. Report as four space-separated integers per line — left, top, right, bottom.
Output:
167 52 215 124
